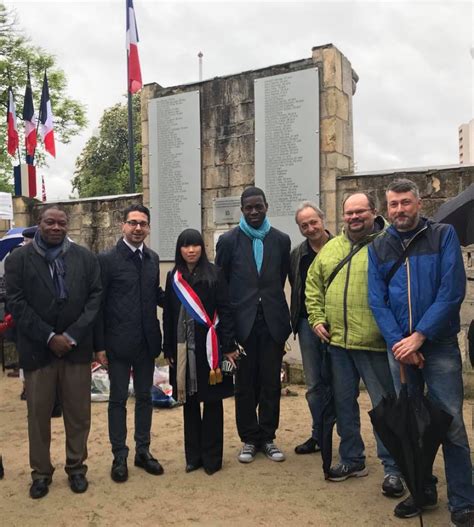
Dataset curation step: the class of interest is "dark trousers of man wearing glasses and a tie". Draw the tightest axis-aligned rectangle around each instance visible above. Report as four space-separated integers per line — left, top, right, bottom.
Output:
109 353 155 457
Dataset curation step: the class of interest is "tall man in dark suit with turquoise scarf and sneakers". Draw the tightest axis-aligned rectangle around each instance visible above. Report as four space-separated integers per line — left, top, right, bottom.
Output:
216 187 291 463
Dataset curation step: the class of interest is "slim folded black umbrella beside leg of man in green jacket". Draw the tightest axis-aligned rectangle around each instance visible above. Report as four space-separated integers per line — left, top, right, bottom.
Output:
316 344 336 479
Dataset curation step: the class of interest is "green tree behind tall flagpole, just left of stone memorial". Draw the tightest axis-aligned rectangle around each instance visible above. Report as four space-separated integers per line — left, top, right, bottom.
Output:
72 94 142 198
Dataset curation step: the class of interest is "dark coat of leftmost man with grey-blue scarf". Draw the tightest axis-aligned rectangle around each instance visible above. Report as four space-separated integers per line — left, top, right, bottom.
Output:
5 243 102 370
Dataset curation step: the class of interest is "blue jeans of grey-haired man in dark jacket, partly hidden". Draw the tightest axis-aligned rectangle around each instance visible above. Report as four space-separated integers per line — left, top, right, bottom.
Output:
297 318 322 439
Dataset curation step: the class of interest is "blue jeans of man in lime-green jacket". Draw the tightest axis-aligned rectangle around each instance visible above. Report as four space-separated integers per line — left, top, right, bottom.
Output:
328 346 400 475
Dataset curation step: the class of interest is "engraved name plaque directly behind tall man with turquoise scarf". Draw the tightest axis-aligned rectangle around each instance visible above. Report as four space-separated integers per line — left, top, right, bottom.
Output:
254 68 319 246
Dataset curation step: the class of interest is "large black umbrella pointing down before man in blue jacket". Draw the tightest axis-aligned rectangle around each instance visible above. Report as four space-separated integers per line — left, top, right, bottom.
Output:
369 365 453 525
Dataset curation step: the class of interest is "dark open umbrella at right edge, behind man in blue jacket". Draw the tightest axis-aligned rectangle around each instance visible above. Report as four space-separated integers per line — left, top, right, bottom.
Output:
433 183 474 246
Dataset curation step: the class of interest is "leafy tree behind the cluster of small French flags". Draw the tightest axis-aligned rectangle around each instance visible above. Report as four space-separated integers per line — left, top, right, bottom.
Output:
0 3 87 191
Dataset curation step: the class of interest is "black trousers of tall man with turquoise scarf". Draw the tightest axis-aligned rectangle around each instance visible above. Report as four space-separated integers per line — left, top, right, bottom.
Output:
235 311 284 446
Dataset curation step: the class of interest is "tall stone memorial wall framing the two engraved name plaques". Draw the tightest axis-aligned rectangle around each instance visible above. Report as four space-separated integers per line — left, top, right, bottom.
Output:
142 44 357 256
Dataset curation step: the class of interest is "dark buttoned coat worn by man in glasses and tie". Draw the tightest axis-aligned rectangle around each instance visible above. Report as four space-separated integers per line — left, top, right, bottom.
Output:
95 240 164 360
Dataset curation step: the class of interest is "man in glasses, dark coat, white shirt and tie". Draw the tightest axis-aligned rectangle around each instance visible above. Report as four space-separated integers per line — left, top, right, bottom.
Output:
95 205 163 482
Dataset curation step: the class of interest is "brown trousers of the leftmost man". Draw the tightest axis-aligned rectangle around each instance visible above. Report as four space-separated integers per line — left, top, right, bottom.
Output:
25 358 91 480
